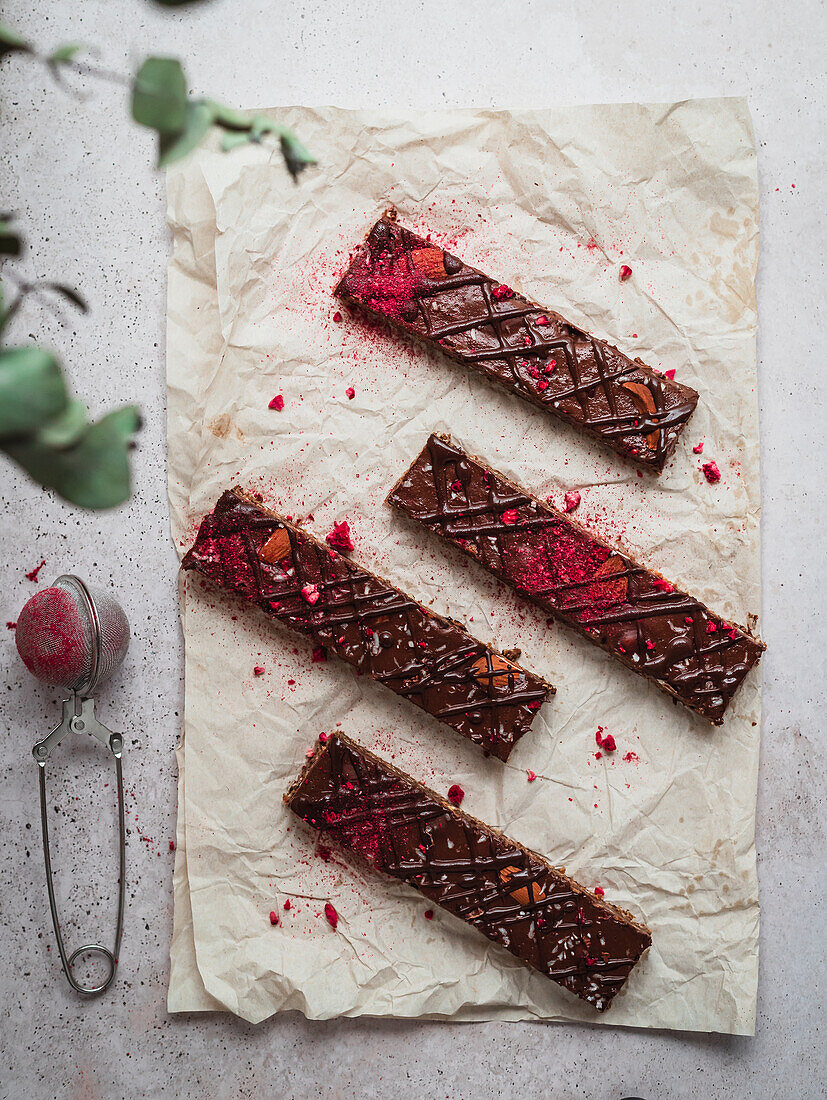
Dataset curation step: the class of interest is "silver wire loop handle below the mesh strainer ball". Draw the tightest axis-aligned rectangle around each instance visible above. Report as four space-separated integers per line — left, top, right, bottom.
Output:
32 696 126 997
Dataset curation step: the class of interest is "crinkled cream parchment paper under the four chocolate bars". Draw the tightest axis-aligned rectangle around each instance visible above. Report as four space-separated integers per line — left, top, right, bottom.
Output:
162 99 760 1033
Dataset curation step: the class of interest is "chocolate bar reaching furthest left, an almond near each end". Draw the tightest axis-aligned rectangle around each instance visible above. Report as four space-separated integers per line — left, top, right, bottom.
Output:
183 488 554 760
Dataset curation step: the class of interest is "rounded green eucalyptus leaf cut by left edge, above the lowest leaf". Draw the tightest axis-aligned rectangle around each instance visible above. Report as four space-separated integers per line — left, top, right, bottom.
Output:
0 347 68 439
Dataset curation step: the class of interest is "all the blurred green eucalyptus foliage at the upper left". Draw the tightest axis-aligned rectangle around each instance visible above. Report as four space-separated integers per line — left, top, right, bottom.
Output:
0 8 316 508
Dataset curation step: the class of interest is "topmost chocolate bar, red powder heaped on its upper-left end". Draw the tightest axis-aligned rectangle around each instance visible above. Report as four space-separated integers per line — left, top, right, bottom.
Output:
334 211 698 473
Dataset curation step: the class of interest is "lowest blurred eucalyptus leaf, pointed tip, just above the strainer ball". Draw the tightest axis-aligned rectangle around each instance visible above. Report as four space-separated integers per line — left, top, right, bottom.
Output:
3 406 141 508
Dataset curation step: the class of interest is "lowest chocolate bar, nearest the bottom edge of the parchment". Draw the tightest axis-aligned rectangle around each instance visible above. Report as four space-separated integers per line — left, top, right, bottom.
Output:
285 734 652 1012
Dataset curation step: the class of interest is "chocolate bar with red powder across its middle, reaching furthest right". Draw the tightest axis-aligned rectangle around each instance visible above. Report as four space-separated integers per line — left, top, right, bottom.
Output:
388 436 765 726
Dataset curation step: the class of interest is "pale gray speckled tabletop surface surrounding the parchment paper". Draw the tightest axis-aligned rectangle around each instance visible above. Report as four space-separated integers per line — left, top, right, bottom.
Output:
0 0 827 1100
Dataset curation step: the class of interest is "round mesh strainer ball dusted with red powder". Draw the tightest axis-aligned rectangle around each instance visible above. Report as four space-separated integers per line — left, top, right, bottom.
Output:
15 575 130 695
